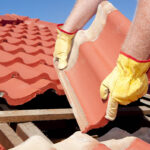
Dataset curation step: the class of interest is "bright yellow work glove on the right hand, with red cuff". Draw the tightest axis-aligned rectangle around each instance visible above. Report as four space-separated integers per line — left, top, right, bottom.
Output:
100 52 150 121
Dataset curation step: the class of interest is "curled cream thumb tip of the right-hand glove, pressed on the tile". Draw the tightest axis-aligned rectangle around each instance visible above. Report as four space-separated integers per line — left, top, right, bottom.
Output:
100 82 109 100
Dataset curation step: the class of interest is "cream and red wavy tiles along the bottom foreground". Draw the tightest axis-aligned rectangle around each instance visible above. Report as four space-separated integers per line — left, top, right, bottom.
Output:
10 131 150 150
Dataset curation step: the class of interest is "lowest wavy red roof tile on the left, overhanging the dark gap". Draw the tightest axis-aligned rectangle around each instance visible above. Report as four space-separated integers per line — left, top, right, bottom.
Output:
0 78 63 106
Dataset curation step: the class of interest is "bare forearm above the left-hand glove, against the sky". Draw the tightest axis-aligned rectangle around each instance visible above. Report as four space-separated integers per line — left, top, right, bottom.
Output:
63 0 104 32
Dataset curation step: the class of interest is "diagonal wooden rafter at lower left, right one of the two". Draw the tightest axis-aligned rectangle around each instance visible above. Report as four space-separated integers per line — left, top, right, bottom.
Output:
16 122 53 144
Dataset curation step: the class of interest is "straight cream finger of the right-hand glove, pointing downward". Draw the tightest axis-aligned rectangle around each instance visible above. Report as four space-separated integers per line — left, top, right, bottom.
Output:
105 96 119 121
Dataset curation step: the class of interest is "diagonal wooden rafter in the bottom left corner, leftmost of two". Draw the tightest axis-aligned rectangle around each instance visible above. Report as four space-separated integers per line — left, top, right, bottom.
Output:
0 123 23 149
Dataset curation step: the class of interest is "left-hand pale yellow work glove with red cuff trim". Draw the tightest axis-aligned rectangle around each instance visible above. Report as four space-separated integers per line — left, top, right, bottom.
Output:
53 24 76 69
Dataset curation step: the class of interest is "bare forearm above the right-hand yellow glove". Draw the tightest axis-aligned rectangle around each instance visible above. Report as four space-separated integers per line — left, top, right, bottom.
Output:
122 0 150 60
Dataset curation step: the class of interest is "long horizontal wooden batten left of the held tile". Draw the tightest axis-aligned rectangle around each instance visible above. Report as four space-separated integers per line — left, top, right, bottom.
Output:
0 108 74 122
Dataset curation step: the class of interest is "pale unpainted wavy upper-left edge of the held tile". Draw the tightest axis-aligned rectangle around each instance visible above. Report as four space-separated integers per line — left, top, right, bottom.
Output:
66 1 116 70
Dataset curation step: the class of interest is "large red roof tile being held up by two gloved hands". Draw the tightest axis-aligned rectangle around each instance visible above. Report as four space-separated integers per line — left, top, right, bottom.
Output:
56 1 150 132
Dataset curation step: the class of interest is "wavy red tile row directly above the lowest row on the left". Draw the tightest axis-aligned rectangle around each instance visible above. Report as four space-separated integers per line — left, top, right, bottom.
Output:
6 63 59 84
